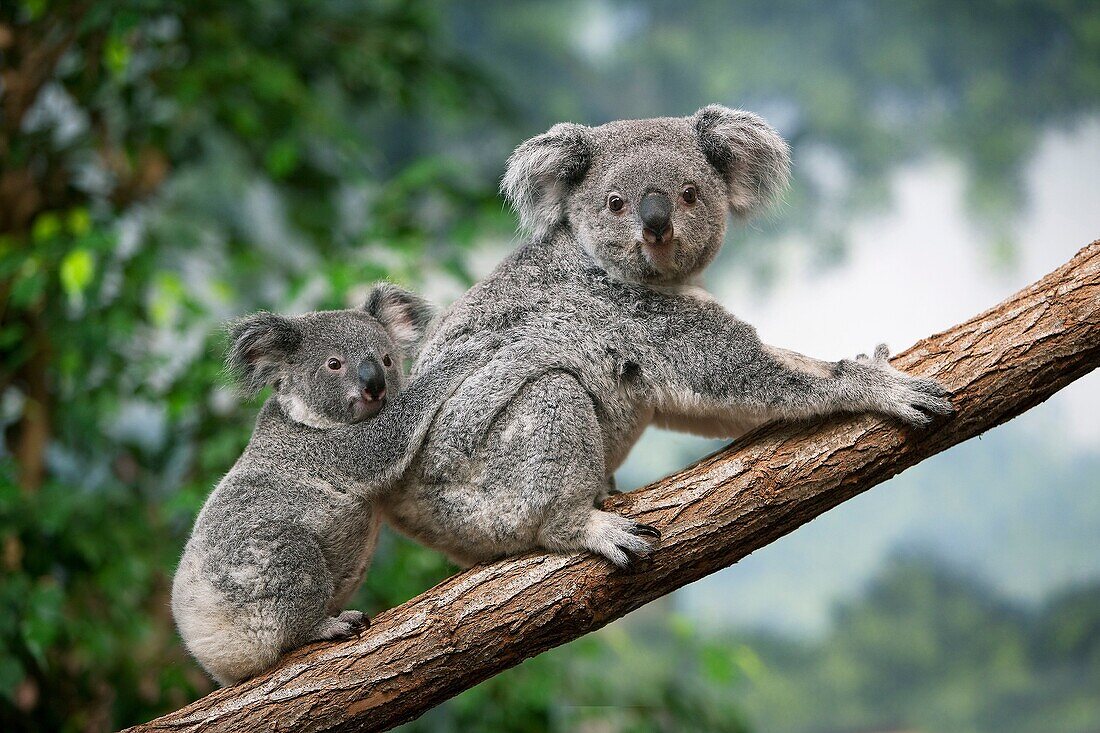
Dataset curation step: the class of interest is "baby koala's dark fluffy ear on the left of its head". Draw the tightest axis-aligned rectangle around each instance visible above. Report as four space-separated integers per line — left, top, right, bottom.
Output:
226 310 301 394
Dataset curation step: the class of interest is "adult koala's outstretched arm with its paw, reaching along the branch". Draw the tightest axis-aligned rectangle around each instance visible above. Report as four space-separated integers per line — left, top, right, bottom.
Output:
642 299 952 435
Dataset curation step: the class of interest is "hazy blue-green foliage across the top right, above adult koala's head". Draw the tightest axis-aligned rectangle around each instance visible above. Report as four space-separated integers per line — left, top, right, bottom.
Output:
452 0 1100 256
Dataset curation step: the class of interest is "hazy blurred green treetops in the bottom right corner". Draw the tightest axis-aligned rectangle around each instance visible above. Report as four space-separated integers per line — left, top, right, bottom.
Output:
739 557 1100 733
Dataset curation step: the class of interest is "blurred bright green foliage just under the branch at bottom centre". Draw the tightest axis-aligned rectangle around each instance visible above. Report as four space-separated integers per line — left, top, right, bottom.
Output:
398 613 756 733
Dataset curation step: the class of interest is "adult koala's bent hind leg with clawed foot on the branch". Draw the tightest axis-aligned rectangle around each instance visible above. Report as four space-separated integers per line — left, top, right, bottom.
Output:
496 373 660 567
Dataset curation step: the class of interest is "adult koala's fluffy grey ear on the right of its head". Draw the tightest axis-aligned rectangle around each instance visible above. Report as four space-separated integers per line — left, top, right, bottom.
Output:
692 105 791 217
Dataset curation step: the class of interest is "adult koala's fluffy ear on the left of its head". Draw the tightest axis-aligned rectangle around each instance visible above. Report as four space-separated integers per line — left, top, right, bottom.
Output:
501 122 593 237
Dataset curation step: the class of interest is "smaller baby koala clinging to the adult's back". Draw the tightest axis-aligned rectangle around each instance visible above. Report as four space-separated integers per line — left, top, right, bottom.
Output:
172 284 464 685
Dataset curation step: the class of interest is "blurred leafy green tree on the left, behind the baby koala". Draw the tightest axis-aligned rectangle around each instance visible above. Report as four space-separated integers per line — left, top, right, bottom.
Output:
0 0 510 731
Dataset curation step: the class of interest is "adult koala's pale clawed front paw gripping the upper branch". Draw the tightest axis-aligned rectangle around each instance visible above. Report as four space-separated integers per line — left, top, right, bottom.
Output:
840 343 954 426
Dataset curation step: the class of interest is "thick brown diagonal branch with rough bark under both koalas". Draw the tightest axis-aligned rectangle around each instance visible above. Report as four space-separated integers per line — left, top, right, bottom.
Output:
131 241 1100 731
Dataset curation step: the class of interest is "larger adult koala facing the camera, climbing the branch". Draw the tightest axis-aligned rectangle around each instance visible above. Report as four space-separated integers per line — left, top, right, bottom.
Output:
384 106 950 566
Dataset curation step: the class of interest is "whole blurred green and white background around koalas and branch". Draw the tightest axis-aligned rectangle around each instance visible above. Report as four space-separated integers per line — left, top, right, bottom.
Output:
0 0 1100 733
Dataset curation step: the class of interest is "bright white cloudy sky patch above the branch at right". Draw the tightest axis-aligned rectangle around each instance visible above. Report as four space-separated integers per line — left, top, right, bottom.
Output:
714 121 1100 445
